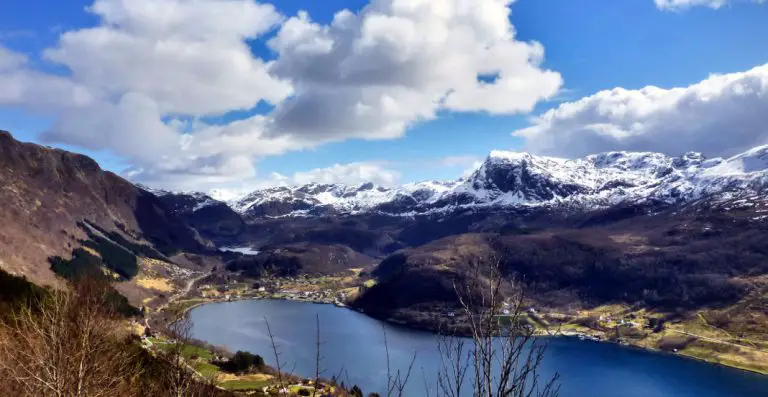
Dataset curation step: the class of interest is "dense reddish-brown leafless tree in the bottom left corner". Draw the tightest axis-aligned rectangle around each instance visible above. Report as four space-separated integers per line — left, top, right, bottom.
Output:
0 280 141 397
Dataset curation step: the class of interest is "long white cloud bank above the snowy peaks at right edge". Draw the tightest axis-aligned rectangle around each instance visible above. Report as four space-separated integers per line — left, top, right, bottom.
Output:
514 64 768 157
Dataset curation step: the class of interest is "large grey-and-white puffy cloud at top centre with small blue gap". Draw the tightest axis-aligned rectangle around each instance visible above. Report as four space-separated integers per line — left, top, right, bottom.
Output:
270 0 562 140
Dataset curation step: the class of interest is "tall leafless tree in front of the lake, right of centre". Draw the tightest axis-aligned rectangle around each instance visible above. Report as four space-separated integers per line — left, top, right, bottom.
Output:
427 258 559 397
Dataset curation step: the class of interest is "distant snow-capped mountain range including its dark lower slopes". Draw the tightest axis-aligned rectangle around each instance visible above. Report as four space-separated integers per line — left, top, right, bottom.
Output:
141 147 768 264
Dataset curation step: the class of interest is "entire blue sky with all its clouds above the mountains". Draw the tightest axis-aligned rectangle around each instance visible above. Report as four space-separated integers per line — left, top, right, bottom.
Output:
0 0 768 198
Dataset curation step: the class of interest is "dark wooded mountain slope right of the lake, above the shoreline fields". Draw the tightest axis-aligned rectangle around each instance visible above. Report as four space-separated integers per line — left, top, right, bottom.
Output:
355 197 768 334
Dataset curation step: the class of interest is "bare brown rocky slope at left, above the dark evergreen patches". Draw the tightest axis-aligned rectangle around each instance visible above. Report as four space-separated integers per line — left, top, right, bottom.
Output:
0 131 207 283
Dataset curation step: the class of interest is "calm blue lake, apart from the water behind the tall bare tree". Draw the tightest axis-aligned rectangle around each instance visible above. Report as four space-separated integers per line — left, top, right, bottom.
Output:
190 300 768 397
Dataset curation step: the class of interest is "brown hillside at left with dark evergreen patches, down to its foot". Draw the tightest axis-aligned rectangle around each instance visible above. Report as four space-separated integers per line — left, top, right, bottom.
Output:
0 131 222 307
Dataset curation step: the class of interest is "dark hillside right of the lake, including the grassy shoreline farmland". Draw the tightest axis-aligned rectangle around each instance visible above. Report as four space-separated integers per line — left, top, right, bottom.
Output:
354 202 768 373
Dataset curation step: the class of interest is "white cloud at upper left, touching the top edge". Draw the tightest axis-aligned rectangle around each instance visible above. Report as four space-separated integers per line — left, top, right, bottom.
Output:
45 0 291 116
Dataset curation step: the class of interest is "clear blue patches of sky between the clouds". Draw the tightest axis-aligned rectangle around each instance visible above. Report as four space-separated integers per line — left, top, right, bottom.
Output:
0 0 768 193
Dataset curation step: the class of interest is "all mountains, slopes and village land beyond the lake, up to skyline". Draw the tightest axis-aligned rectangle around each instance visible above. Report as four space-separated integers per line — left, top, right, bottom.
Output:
0 133 768 392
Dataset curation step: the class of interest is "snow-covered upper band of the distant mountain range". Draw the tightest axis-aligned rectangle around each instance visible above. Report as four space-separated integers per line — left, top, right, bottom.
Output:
170 146 768 219
